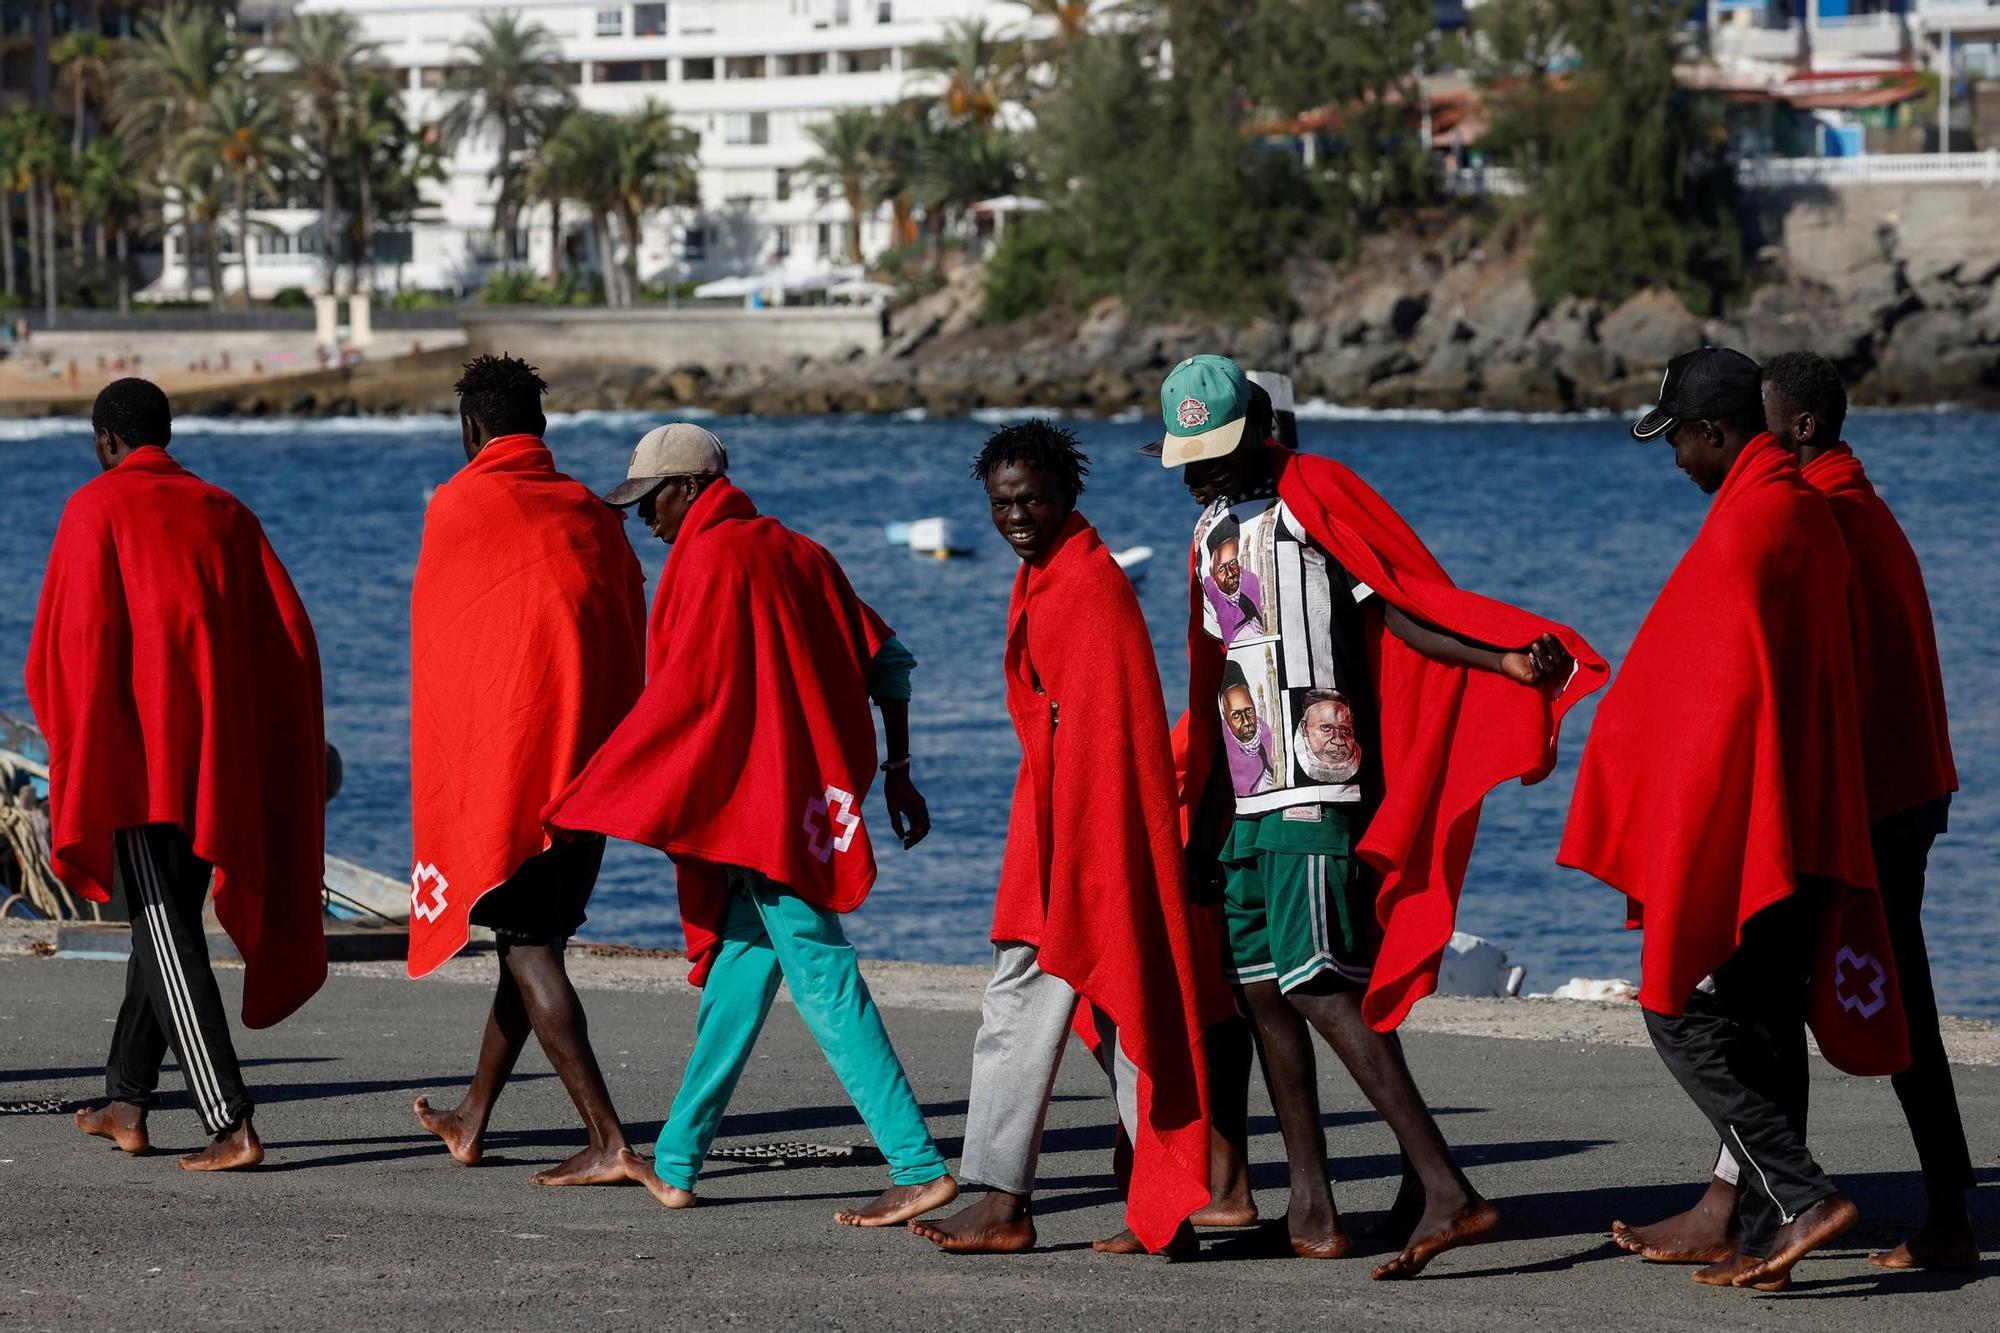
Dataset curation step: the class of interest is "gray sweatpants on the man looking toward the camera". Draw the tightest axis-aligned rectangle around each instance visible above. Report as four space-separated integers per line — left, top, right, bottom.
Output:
958 943 1138 1195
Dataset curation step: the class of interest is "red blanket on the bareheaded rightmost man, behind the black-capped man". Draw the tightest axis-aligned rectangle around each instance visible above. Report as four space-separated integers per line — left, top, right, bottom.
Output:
1804 444 1958 819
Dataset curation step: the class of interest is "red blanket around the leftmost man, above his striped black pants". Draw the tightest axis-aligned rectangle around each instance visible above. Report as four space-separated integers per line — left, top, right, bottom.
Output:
28 448 326 1027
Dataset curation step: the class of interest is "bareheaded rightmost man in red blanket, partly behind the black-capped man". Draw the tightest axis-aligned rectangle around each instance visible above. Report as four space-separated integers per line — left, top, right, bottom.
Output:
1612 352 1978 1271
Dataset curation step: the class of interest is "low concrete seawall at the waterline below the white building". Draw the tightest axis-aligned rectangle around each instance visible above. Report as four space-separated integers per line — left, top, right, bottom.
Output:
464 308 882 374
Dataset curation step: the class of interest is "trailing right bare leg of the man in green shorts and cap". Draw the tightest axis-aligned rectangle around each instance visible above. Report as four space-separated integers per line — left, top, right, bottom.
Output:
1286 989 1500 1279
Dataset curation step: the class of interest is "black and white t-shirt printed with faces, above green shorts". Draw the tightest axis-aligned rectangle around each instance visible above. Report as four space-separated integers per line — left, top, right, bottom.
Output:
1194 498 1378 819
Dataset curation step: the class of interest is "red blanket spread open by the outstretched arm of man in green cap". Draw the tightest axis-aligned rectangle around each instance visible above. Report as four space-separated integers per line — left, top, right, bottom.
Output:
1182 448 1610 1033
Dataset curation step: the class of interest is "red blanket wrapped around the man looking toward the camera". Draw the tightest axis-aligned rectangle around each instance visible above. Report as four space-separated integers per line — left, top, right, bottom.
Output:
992 514 1234 1251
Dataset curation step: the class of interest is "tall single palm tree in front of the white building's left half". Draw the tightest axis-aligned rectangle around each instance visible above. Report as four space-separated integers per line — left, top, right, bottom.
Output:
444 10 570 264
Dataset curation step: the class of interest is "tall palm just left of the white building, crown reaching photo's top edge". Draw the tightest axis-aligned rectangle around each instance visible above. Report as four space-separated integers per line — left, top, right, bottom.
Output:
110 6 242 292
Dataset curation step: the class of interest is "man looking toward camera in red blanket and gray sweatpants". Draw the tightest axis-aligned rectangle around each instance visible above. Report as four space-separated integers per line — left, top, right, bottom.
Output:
912 420 1232 1253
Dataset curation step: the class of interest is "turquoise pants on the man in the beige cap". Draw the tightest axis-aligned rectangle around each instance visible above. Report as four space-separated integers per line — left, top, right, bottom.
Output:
652 867 944 1189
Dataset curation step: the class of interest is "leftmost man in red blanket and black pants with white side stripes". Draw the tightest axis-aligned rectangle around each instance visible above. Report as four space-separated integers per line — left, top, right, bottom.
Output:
28 378 328 1171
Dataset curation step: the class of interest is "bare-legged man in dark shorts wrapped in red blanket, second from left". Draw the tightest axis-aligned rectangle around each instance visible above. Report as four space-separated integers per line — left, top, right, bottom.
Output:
410 356 646 1185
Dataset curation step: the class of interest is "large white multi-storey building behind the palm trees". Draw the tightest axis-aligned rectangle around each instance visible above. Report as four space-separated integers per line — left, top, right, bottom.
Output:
154 0 1028 298
